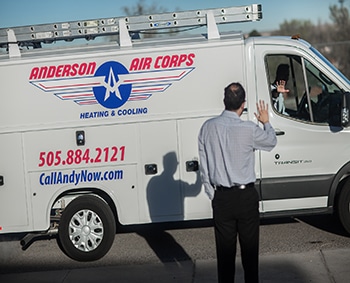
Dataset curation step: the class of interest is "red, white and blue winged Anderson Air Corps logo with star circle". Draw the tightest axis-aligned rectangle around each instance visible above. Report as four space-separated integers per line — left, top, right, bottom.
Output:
29 53 195 109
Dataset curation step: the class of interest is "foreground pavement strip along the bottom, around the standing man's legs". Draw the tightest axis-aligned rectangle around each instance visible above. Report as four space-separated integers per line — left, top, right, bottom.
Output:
0 248 350 283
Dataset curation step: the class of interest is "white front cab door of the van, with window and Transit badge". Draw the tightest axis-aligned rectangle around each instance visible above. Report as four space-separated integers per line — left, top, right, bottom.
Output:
255 45 348 213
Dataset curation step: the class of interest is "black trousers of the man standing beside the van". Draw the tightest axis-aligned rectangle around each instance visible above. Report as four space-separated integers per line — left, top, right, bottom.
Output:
212 187 260 283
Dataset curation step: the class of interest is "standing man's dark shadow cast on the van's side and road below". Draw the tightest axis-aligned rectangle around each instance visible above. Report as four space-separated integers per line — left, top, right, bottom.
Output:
137 152 201 263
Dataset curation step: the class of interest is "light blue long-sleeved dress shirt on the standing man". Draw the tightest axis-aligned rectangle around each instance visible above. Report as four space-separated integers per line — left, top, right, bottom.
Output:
198 110 277 199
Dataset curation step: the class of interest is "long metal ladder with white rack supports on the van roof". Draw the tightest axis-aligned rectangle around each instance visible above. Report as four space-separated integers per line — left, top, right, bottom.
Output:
0 4 262 57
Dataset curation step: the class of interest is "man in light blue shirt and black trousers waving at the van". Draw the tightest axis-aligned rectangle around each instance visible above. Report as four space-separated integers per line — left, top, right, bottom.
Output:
198 83 277 283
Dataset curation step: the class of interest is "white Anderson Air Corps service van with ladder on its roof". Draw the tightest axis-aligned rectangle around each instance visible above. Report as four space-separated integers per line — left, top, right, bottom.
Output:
0 4 350 261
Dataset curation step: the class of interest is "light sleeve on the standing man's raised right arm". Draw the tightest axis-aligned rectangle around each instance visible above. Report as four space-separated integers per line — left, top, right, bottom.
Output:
254 122 277 151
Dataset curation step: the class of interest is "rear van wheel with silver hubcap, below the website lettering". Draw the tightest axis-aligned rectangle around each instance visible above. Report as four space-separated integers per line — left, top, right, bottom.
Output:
57 195 116 261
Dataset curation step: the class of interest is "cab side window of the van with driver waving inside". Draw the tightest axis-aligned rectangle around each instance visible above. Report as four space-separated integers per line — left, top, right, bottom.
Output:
265 55 342 126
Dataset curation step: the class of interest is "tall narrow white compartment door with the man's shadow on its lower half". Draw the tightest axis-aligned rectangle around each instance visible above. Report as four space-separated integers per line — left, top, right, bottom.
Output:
139 120 184 222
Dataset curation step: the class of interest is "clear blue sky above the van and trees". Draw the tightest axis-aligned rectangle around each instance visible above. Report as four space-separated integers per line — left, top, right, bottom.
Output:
0 0 350 32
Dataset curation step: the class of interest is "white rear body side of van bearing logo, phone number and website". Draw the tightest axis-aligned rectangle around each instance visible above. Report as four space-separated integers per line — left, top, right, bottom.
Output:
0 35 245 233
